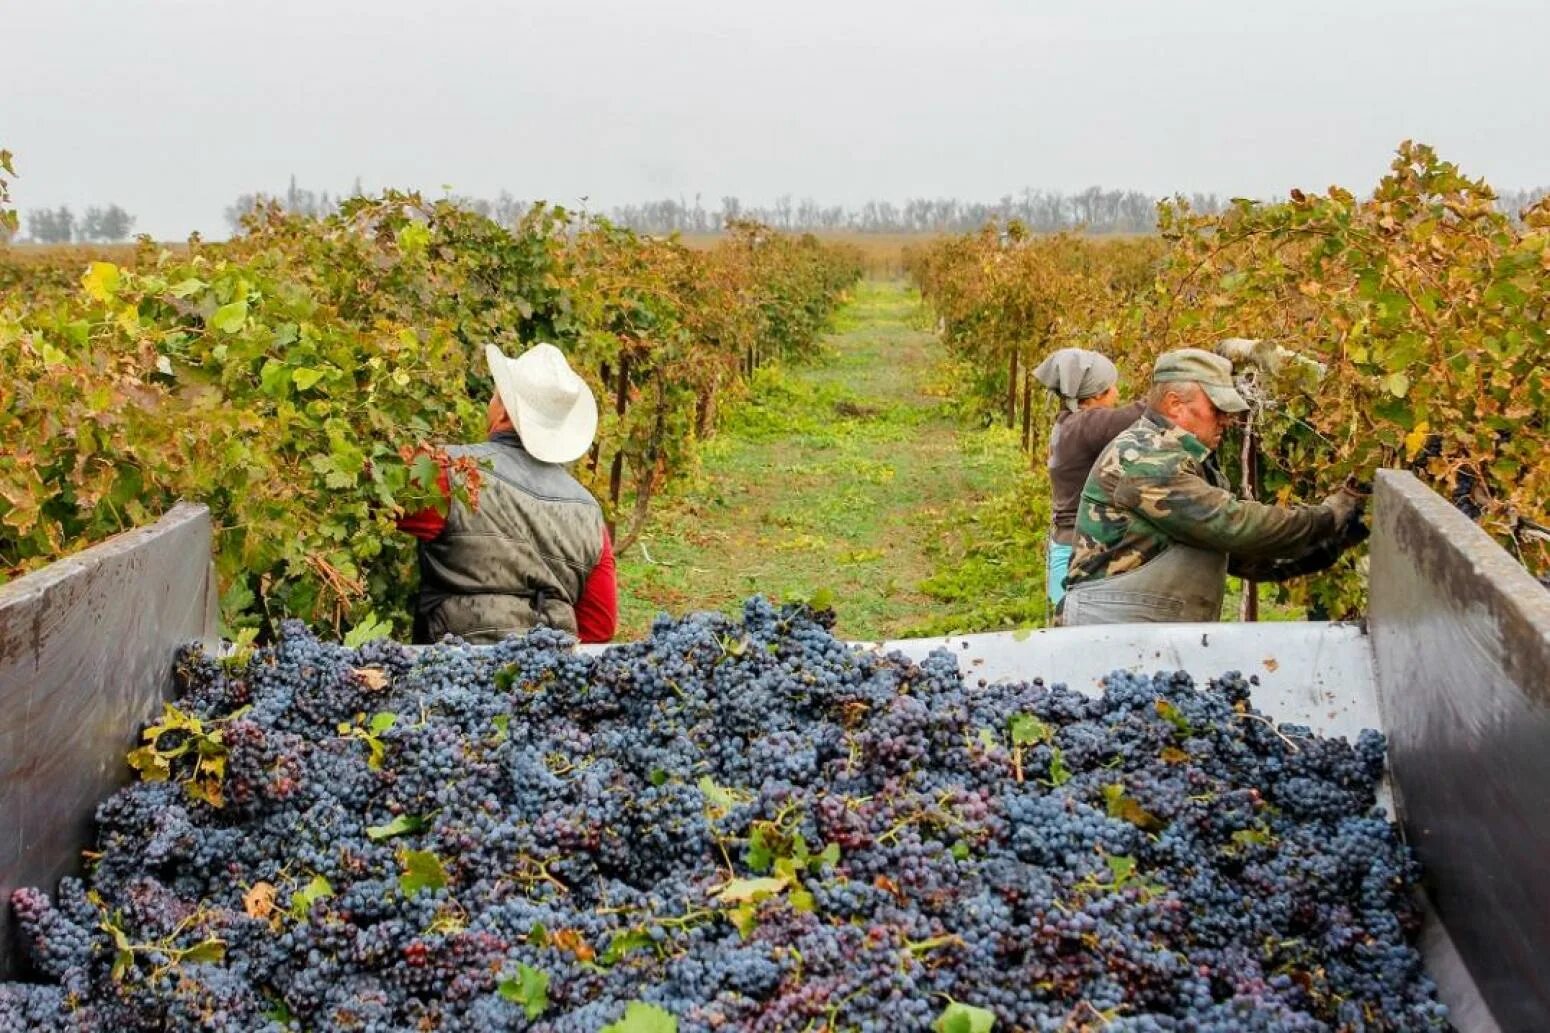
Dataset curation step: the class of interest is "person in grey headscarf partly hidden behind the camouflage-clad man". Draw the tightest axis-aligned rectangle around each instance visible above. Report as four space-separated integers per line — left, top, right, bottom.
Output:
1034 347 1145 606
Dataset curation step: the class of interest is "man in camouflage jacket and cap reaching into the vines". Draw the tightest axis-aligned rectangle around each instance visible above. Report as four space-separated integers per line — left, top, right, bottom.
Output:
1060 347 1364 625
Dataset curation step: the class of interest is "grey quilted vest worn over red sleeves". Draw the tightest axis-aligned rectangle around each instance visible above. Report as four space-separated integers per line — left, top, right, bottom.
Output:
414 433 603 642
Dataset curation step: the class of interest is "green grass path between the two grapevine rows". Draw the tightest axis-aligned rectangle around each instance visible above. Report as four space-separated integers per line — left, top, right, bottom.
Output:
620 281 1048 639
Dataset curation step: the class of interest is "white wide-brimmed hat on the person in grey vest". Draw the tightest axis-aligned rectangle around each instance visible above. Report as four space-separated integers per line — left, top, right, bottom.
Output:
485 344 597 462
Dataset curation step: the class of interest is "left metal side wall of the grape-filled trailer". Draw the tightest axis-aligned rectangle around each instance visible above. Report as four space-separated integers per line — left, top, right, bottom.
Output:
0 504 215 979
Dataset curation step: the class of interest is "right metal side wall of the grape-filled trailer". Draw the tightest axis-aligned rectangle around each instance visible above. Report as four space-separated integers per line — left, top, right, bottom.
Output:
1370 472 1550 1033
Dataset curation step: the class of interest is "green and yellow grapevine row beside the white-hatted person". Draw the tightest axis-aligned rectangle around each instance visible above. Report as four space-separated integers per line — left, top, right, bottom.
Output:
0 192 859 637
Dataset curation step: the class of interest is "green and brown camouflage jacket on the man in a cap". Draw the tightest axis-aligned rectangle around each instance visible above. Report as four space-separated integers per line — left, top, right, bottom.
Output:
1066 409 1336 588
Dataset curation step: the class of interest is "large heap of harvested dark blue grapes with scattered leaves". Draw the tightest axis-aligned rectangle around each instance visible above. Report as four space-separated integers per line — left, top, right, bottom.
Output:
0 599 1448 1033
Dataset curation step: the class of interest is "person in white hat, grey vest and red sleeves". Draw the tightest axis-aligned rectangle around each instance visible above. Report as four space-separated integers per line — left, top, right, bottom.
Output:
398 344 618 642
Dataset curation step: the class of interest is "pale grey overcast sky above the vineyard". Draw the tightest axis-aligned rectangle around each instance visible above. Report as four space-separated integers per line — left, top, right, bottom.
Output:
0 0 1550 239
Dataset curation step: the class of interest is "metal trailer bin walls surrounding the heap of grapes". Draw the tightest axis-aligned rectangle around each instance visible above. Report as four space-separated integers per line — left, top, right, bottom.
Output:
0 472 1550 1033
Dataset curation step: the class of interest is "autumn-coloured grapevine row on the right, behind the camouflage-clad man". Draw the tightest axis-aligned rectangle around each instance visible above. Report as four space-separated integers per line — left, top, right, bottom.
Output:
913 143 1550 617
